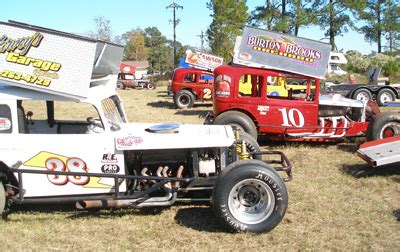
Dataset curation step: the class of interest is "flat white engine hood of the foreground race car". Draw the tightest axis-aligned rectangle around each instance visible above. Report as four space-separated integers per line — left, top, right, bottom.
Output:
115 123 235 150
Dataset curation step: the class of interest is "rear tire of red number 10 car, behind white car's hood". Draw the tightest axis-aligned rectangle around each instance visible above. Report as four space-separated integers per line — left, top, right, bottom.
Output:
214 111 258 139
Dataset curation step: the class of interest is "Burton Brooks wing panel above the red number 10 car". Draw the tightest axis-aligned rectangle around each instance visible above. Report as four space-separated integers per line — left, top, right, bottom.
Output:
233 27 330 79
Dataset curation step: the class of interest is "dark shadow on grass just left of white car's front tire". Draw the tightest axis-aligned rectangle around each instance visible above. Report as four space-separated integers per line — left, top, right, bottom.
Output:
175 207 226 233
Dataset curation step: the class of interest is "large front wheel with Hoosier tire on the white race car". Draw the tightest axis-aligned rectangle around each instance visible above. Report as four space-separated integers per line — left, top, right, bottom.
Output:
212 160 289 233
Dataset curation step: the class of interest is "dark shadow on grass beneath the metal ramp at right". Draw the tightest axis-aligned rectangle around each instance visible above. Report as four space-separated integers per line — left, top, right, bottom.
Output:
341 163 400 178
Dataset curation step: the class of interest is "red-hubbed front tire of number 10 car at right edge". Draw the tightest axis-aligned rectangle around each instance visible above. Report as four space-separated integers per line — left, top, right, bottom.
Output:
366 112 400 141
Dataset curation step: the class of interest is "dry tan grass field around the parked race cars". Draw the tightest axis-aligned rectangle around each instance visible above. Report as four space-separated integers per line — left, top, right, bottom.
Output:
0 87 400 251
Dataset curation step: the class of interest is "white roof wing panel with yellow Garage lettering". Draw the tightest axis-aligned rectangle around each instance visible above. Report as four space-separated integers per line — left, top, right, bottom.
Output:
0 22 122 98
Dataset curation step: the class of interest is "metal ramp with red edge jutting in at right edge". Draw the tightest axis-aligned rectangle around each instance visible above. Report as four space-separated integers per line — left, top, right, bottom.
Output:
357 135 400 167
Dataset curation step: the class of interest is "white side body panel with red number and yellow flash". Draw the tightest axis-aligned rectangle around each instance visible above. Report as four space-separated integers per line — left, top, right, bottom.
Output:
0 101 126 198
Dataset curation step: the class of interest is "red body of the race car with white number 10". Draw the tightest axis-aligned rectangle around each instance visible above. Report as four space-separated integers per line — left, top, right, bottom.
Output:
214 67 319 134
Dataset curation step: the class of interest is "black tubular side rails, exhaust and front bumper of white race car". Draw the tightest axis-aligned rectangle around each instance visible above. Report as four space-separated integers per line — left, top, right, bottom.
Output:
0 150 292 213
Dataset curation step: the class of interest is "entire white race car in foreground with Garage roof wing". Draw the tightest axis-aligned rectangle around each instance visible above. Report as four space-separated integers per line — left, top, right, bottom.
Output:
0 22 292 232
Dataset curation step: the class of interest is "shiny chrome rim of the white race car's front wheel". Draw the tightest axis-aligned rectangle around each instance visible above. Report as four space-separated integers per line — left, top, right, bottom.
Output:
228 179 275 224
